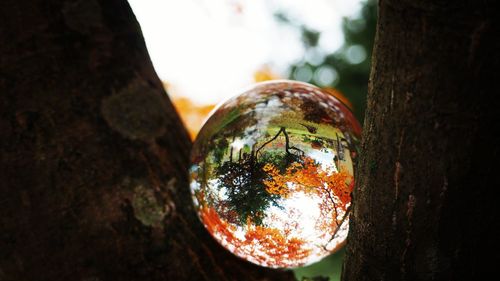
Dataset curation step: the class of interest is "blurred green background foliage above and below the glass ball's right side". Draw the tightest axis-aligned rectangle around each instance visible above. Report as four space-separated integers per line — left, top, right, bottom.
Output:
276 0 377 281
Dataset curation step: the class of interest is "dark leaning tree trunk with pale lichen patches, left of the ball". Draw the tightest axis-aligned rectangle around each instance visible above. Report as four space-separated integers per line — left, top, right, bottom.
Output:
0 0 293 281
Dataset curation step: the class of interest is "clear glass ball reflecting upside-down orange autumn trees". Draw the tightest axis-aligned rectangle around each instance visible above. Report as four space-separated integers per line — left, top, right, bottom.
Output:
190 80 361 268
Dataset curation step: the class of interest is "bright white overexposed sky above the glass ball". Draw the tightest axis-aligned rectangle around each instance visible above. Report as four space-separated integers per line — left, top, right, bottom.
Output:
129 0 361 104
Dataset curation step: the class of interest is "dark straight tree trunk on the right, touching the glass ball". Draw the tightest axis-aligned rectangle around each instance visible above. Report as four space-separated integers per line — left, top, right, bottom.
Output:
342 0 500 281
